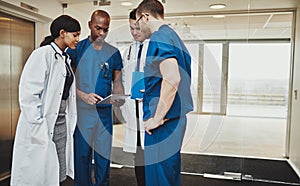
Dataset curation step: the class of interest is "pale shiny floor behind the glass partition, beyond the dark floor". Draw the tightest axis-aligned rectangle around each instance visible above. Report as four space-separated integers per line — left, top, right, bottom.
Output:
113 114 286 159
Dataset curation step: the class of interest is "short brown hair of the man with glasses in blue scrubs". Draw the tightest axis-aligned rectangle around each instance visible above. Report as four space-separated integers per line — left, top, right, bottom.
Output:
137 0 164 19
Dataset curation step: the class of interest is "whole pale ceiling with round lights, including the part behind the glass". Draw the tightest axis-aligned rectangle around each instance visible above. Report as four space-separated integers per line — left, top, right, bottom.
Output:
59 0 300 40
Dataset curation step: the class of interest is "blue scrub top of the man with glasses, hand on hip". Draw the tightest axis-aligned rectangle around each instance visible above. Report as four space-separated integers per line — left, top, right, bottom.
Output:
143 25 193 120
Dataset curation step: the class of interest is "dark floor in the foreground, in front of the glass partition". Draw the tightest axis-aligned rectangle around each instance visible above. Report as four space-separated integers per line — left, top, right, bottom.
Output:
0 148 300 186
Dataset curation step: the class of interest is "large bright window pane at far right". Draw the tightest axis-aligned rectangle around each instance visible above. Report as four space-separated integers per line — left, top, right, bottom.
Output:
227 43 291 118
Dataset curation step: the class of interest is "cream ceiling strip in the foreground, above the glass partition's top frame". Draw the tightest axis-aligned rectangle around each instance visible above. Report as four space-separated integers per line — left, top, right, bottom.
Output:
59 0 300 17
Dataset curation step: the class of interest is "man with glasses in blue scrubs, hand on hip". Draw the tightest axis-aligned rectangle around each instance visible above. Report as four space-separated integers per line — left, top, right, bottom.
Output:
136 0 193 186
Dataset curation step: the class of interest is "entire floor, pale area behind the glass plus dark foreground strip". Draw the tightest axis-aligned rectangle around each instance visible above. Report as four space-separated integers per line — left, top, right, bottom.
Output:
0 111 292 186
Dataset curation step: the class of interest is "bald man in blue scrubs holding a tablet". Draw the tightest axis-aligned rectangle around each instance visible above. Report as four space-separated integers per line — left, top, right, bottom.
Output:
67 10 124 186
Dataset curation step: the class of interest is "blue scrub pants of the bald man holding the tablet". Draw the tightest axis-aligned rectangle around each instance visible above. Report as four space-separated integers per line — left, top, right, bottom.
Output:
74 107 112 186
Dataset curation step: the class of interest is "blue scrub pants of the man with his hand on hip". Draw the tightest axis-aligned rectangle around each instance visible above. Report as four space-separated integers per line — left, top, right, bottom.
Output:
145 116 187 186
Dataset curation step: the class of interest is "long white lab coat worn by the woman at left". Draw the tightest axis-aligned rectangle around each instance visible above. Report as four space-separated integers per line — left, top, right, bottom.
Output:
11 43 77 186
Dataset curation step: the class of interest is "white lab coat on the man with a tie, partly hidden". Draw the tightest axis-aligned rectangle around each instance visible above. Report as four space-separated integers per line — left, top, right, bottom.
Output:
121 40 149 153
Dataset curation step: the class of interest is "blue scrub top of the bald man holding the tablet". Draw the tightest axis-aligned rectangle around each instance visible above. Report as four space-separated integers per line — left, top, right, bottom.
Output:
67 38 123 107
